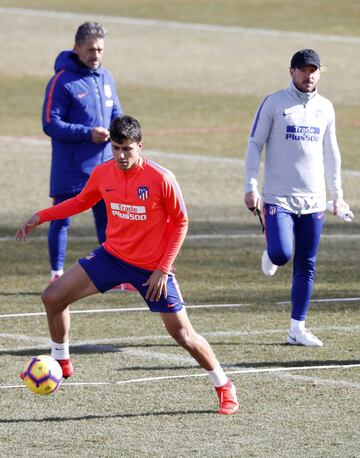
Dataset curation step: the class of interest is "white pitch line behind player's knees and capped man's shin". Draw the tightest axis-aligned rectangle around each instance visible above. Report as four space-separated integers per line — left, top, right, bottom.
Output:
0 297 360 318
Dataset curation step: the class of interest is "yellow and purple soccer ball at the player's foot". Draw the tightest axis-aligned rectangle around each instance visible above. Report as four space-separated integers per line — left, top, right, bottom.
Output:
22 355 63 395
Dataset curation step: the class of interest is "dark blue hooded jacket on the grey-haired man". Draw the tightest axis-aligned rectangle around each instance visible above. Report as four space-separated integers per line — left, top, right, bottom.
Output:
42 51 122 197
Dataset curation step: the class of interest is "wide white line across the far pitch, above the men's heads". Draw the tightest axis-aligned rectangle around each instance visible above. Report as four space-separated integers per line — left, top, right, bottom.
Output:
0 7 360 44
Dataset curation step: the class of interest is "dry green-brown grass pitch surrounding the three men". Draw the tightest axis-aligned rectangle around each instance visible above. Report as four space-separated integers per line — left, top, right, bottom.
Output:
0 0 360 458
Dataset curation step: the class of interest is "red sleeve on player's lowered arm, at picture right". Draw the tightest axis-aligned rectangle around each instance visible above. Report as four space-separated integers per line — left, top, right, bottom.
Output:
157 174 188 273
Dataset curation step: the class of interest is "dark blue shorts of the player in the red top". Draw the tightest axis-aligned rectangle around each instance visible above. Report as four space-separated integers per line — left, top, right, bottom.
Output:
79 246 184 313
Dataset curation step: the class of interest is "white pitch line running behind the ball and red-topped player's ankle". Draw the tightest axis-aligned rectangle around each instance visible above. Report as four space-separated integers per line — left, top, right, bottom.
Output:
0 364 360 390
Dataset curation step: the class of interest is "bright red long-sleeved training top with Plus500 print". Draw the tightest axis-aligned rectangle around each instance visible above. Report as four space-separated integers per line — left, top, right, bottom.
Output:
37 157 188 273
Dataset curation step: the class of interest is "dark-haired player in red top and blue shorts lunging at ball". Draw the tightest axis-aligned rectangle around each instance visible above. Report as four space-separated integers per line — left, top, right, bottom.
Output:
16 115 239 414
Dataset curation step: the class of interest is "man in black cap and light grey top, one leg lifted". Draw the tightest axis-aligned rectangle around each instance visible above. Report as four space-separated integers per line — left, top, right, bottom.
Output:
245 49 348 347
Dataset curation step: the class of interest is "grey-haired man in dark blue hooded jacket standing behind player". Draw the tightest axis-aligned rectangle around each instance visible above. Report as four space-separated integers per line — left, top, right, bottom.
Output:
42 22 123 280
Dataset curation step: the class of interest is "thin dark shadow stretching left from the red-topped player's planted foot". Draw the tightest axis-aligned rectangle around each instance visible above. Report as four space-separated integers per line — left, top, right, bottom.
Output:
0 410 214 424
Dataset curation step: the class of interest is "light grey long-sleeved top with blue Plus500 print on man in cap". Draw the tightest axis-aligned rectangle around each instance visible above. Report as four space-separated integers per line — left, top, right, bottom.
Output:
245 82 343 213
